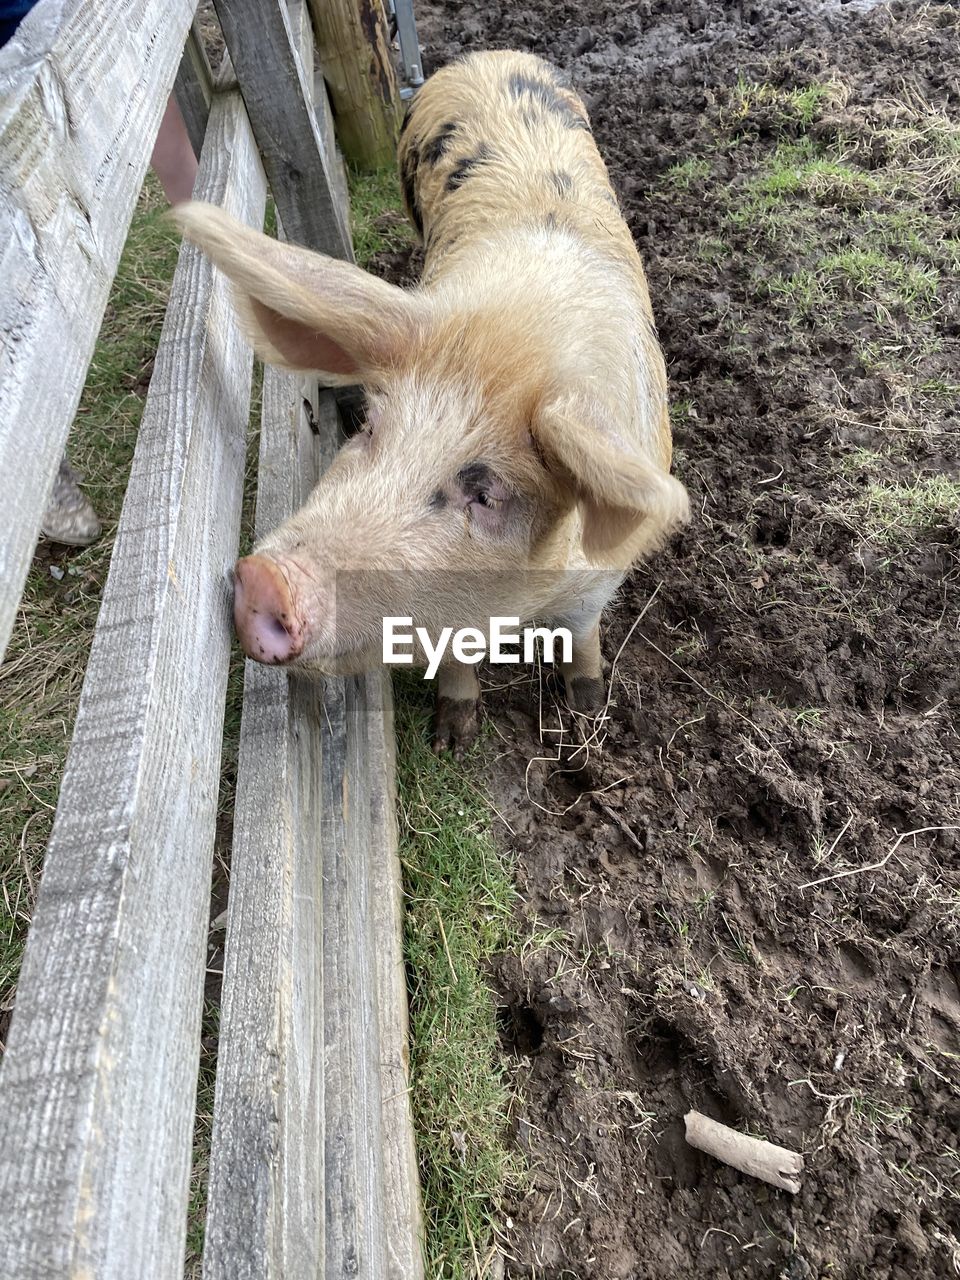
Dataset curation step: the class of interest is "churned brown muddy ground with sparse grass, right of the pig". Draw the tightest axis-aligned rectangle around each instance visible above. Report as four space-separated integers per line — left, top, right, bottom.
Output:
378 0 960 1280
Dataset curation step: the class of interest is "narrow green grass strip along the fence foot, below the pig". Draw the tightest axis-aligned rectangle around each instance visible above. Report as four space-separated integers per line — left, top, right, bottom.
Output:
394 676 522 1280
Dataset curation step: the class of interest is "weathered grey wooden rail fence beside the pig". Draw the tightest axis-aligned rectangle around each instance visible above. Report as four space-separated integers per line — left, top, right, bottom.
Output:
0 0 422 1280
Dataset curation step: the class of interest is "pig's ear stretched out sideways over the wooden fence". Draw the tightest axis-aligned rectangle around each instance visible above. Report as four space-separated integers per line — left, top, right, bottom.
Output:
173 201 424 384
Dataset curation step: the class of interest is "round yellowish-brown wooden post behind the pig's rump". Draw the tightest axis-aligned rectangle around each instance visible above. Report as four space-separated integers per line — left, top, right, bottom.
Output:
308 0 402 169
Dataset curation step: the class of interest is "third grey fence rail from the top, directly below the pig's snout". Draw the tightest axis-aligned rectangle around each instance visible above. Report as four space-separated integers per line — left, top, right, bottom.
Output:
204 369 330 1280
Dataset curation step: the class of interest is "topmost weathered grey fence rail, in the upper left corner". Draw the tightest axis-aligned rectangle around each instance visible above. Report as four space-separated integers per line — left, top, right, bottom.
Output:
0 0 196 655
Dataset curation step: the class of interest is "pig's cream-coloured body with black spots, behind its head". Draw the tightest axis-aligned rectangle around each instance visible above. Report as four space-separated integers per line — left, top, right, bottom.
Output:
398 52 671 481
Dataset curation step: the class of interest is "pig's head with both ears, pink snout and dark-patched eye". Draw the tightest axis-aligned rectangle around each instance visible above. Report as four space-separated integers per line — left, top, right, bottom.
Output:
177 204 686 673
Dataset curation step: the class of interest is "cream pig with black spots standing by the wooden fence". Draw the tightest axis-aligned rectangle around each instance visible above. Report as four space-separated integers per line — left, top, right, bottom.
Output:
177 51 687 755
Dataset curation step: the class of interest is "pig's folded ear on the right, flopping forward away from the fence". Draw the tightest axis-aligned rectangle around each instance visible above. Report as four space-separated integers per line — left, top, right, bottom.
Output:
534 403 689 561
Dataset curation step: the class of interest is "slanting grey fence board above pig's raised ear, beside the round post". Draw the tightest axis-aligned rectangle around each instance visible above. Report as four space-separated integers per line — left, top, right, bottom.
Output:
214 0 353 260
